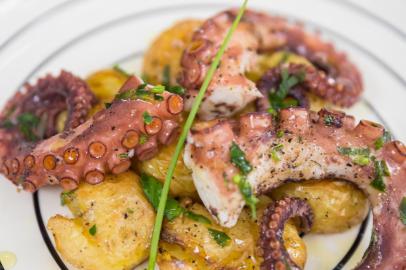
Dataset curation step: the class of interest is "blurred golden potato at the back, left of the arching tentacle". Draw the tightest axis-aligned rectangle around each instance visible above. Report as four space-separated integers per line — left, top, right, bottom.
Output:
142 20 202 85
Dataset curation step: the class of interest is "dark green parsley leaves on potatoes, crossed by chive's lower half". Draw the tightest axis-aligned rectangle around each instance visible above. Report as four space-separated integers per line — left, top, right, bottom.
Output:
141 173 211 224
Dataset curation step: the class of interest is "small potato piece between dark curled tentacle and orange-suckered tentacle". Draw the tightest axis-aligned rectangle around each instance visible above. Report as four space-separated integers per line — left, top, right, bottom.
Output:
86 69 127 104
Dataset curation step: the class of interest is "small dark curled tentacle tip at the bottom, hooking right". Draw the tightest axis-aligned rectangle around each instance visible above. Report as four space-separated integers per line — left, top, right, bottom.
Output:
260 198 313 270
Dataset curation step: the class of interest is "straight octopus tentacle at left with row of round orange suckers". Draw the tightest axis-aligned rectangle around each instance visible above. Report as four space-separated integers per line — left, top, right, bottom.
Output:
1 77 183 192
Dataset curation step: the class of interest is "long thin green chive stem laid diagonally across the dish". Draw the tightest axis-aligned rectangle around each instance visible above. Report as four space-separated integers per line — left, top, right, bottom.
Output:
148 0 248 270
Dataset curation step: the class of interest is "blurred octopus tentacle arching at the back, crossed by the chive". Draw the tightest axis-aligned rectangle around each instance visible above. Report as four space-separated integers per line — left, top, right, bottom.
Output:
179 10 363 120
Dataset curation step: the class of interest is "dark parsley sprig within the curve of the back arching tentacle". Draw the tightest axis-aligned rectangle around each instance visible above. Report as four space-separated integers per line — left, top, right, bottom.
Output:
268 68 305 116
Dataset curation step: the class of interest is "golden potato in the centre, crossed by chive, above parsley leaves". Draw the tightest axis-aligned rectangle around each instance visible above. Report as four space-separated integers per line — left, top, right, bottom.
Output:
136 144 197 198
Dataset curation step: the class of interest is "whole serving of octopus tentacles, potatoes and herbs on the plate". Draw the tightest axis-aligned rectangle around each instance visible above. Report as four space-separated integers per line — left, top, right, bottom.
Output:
0 5 406 270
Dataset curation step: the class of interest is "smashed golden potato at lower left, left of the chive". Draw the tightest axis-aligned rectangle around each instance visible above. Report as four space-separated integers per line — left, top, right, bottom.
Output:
48 172 155 270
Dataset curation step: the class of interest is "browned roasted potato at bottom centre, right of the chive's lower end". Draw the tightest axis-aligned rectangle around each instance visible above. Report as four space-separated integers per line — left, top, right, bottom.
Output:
158 197 306 270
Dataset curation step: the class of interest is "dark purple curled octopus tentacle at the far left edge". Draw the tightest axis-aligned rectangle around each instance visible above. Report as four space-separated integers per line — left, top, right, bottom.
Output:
0 71 95 181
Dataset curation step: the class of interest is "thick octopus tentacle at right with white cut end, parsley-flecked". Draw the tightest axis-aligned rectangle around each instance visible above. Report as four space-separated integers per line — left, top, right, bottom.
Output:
184 108 406 270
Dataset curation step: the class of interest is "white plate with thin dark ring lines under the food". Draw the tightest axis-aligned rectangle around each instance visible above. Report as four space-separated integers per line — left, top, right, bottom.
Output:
0 0 406 270
